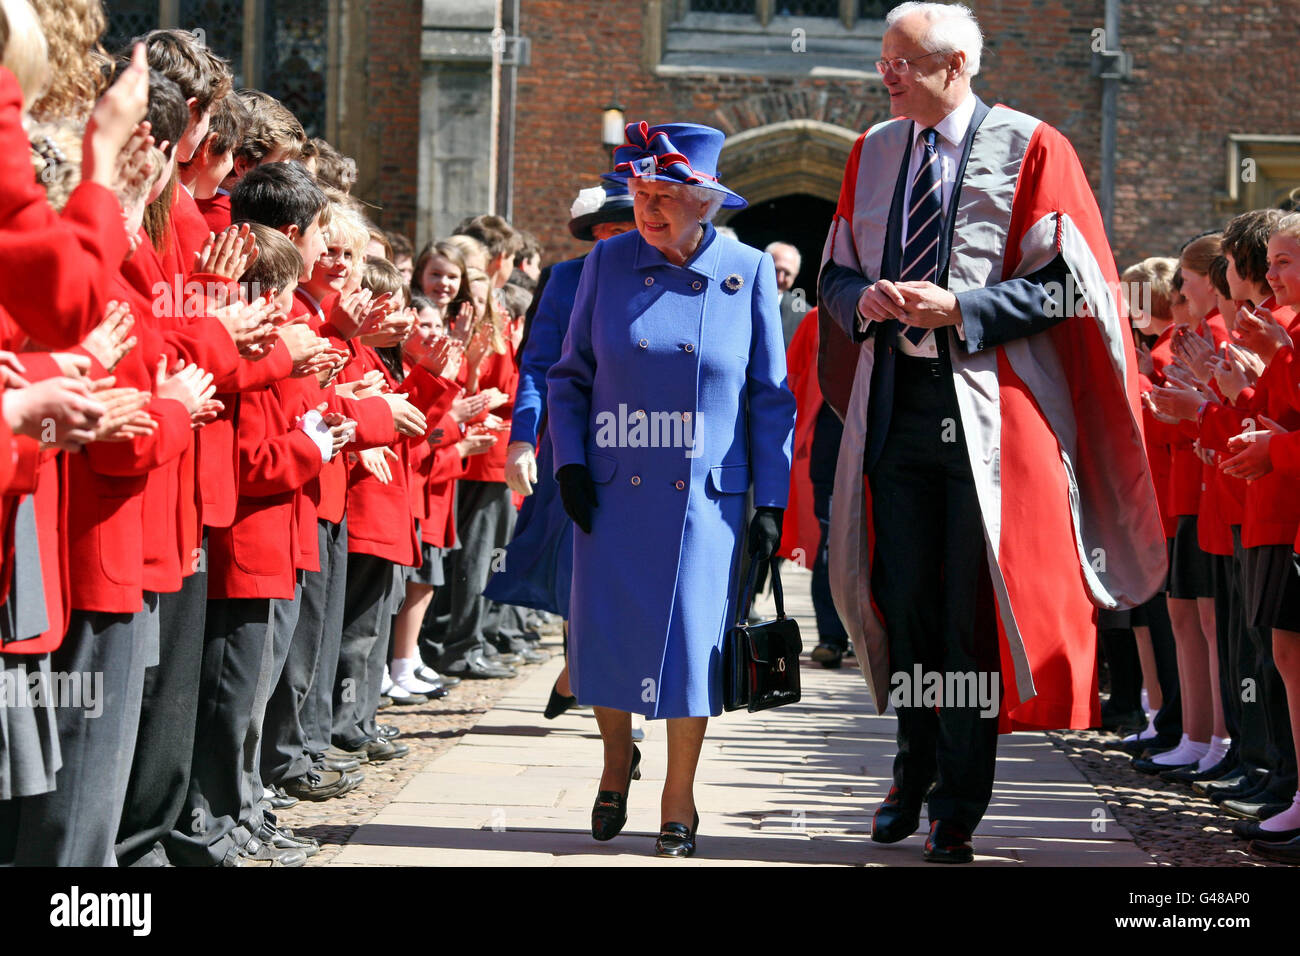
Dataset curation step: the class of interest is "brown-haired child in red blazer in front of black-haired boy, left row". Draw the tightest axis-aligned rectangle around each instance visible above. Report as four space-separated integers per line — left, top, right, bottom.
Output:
173 214 350 864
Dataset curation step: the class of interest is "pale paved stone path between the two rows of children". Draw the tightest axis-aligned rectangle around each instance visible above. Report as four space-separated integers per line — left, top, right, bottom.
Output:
329 571 1152 866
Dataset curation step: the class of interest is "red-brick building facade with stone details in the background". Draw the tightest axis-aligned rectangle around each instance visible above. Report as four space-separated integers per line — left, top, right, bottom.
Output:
108 0 1300 273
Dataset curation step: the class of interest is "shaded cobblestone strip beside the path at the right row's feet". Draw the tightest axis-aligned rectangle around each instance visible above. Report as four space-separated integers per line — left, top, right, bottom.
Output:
1048 730 1283 866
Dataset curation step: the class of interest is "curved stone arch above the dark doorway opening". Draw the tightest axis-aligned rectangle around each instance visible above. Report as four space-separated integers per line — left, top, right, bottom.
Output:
718 120 859 222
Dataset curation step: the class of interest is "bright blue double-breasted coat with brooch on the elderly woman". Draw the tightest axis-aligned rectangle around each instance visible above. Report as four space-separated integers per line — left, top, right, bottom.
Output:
546 224 794 718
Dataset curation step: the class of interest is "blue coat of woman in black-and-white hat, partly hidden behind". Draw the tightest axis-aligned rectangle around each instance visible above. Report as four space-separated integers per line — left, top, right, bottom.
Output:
484 259 582 618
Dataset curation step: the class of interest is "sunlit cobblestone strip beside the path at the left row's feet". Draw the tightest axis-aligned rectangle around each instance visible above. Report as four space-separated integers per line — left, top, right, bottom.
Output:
280 627 562 866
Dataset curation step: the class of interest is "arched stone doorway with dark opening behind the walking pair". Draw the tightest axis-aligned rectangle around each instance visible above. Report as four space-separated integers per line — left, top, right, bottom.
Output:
718 120 858 303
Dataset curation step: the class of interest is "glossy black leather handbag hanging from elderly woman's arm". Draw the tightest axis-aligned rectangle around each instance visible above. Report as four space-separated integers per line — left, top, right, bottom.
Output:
723 561 803 713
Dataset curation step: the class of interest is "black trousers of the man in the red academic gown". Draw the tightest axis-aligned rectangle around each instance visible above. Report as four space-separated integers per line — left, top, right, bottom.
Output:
870 355 1001 830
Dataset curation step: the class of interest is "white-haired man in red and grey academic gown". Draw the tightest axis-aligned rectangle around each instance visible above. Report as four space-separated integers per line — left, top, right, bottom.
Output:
819 7 1165 862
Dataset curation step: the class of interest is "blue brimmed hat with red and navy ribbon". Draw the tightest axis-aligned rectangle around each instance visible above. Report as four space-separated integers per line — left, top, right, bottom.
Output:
603 121 749 209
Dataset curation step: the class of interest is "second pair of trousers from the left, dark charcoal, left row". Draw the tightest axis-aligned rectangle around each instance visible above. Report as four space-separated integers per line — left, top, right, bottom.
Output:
117 561 208 866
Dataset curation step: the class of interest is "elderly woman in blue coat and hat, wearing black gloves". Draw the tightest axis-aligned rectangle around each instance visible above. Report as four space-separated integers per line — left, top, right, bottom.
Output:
546 122 794 856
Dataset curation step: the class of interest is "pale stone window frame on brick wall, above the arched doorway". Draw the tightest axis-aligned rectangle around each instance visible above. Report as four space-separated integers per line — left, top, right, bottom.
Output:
642 0 885 81
